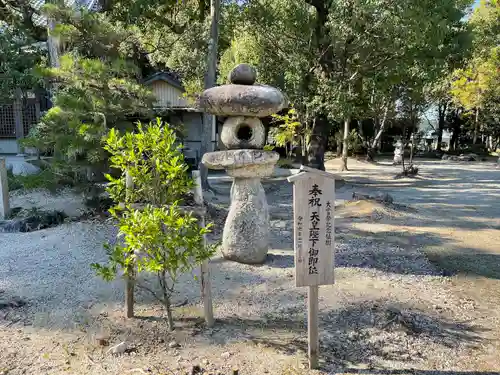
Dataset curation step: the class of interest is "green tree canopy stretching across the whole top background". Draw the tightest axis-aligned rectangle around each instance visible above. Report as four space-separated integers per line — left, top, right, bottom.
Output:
0 0 500 168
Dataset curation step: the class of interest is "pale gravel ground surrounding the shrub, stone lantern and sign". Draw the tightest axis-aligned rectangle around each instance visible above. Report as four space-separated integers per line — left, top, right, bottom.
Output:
0 161 500 375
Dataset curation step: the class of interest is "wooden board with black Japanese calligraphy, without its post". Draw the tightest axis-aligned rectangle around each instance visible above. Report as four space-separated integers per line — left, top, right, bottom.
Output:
293 172 335 286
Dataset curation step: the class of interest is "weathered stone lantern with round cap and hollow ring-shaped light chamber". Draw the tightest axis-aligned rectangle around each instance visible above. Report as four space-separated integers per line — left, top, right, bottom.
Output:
198 64 286 264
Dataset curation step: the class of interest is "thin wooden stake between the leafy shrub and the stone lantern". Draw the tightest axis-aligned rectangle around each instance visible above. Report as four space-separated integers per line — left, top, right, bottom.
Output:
193 171 215 327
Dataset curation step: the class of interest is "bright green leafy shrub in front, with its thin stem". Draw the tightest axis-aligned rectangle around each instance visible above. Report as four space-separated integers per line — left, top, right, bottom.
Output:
92 119 215 329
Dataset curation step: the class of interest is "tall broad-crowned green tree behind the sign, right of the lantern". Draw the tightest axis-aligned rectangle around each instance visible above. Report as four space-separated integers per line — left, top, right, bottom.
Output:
223 0 467 168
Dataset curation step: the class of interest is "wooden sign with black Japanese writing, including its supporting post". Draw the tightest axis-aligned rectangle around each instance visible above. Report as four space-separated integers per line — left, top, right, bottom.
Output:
288 166 335 369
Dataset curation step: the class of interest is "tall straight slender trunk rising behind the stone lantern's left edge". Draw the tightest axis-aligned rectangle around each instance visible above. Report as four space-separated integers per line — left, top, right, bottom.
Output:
199 0 220 190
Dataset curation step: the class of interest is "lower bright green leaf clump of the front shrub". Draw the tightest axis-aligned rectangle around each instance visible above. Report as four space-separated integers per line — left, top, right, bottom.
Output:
93 203 213 282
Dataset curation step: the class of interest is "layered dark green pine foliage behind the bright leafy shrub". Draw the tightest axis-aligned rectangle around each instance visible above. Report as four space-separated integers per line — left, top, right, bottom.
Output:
37 55 152 164
